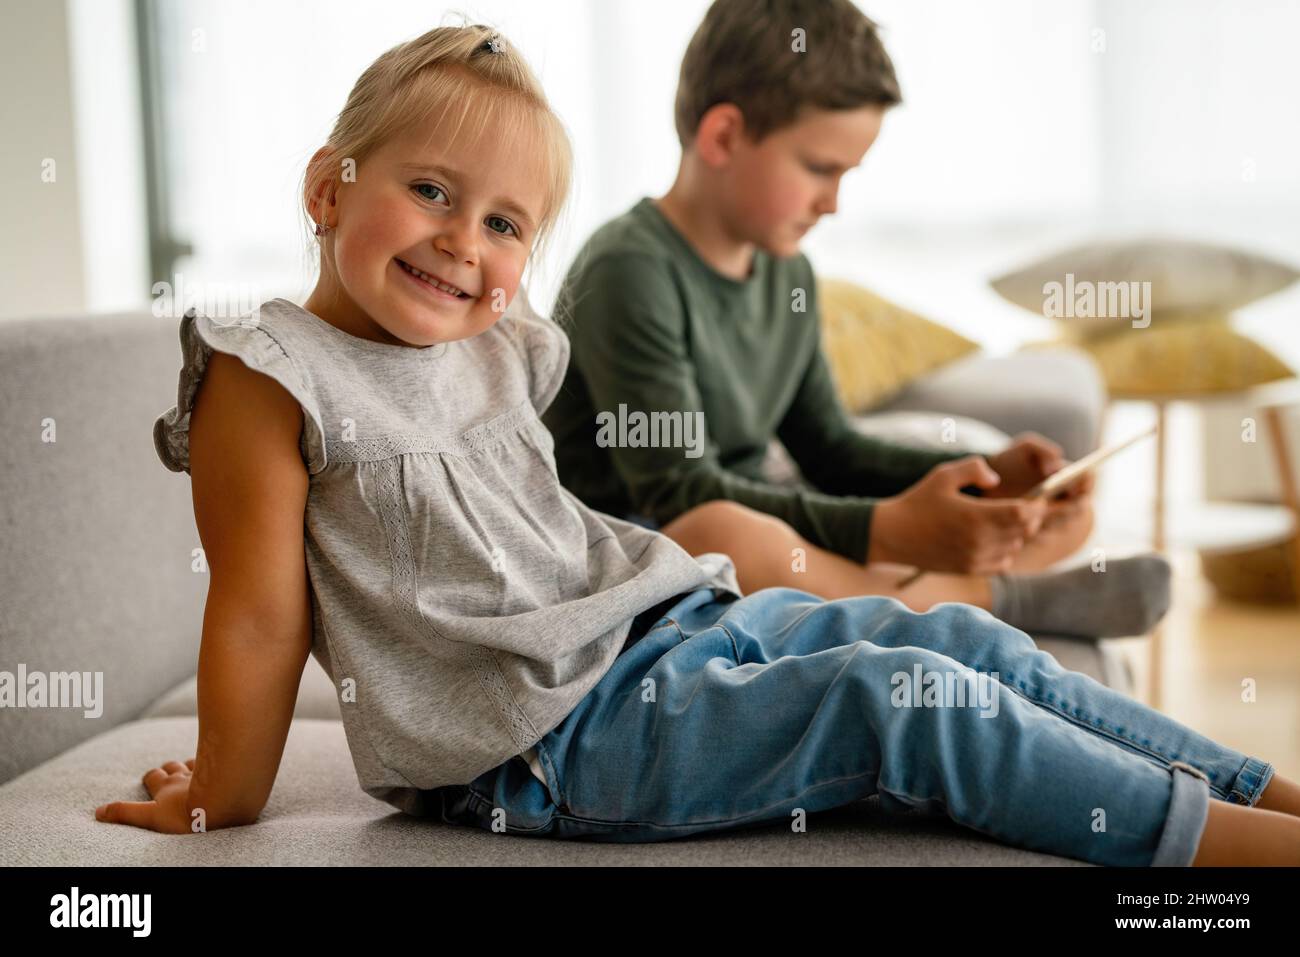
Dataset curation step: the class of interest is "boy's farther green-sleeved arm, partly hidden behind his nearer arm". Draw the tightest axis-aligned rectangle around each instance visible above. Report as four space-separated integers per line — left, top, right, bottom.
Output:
776 330 969 497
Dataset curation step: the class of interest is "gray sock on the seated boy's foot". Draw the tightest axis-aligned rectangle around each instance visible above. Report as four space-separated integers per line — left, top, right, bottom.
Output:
989 553 1170 638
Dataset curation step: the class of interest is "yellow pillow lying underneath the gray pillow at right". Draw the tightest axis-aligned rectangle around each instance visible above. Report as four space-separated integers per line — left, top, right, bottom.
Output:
1036 315 1295 399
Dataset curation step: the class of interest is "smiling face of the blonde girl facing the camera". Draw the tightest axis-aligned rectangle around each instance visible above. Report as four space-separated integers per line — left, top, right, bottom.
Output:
306 102 545 347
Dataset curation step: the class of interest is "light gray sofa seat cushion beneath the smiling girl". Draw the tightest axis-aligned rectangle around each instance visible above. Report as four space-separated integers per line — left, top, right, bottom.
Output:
0 718 1087 866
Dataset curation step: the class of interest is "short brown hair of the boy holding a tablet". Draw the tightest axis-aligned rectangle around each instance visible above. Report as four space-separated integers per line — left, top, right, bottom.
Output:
675 0 902 147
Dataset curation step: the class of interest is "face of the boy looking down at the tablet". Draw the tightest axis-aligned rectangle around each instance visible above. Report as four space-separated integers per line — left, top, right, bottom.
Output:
723 105 884 257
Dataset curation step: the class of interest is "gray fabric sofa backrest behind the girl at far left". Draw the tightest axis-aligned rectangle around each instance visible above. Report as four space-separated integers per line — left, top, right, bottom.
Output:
0 313 208 781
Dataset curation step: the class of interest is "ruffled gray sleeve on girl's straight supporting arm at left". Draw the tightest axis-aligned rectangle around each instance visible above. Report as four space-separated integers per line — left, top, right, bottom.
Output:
153 309 326 475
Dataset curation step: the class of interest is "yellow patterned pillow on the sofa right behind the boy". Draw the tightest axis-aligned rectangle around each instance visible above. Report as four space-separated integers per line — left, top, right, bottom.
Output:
818 280 979 413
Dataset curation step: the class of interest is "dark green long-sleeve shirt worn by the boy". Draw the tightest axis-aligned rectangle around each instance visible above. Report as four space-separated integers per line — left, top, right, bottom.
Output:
543 198 959 562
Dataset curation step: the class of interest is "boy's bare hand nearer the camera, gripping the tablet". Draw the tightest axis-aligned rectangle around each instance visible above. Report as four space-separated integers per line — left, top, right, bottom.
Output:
867 455 1048 575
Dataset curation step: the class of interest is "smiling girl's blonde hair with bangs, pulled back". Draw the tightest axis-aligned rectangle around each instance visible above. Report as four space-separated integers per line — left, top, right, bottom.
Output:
302 23 573 268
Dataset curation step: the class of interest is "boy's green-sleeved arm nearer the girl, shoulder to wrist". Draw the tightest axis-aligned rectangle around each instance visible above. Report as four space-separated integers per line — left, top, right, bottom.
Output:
569 256 874 562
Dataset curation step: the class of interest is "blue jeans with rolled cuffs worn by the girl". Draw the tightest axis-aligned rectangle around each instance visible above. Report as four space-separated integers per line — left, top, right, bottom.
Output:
430 588 1273 866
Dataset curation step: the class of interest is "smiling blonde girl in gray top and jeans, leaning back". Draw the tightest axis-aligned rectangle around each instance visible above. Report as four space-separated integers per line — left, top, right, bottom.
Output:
104 26 1300 865
